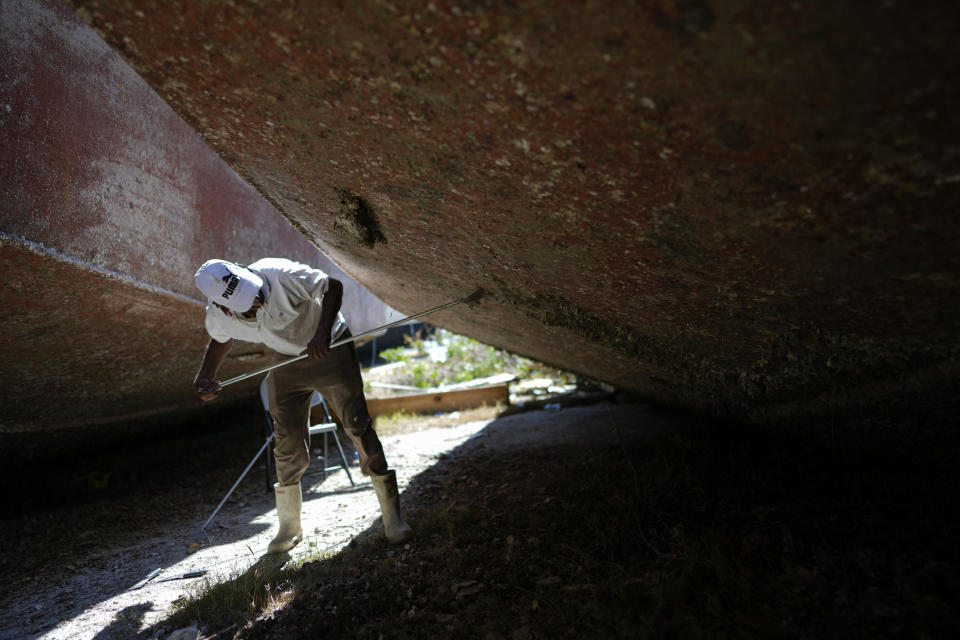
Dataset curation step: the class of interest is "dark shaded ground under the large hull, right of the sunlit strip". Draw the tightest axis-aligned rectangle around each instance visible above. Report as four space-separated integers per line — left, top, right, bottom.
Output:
144 405 960 639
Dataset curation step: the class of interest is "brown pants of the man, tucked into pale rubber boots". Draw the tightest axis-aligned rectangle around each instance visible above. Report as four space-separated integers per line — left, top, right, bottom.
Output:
267 333 387 485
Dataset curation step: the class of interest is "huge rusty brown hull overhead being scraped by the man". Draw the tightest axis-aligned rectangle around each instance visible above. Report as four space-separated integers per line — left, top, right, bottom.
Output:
7 0 960 430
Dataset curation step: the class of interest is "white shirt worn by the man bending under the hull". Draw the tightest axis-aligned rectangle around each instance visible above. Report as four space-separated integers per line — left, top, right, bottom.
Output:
205 258 347 356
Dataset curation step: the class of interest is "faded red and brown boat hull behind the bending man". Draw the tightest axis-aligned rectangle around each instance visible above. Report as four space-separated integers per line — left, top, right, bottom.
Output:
0 2 391 434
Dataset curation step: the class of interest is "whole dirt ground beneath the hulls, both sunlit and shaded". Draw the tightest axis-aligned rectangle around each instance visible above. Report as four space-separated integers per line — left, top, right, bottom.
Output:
0 402 960 640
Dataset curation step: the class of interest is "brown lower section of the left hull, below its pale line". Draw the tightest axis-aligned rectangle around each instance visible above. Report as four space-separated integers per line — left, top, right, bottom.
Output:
0 241 212 432
